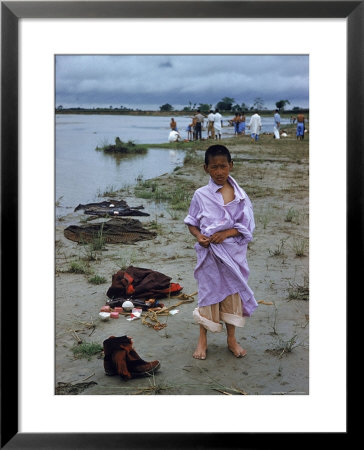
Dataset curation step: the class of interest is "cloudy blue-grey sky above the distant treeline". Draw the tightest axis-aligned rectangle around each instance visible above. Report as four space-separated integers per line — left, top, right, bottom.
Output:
55 55 309 110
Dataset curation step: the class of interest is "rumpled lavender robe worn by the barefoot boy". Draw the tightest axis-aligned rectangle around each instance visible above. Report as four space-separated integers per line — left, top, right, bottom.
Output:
184 176 258 316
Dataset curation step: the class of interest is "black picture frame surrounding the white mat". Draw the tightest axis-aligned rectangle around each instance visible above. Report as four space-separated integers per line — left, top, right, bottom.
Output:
1 0 358 449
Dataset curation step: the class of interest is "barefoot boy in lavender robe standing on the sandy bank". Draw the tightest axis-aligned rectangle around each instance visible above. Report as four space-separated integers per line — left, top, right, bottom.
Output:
184 145 258 359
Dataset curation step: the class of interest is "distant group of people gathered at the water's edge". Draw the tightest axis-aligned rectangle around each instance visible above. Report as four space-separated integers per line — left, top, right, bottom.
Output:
169 109 305 143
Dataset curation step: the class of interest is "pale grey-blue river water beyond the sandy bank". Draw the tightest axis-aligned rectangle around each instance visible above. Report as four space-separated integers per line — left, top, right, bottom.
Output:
55 114 289 216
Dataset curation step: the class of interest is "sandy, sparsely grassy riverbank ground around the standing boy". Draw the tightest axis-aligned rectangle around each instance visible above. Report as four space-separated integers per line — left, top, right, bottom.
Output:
55 132 309 395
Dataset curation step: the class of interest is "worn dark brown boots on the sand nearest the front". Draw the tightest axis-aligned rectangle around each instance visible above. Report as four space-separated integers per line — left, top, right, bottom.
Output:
103 336 160 380
